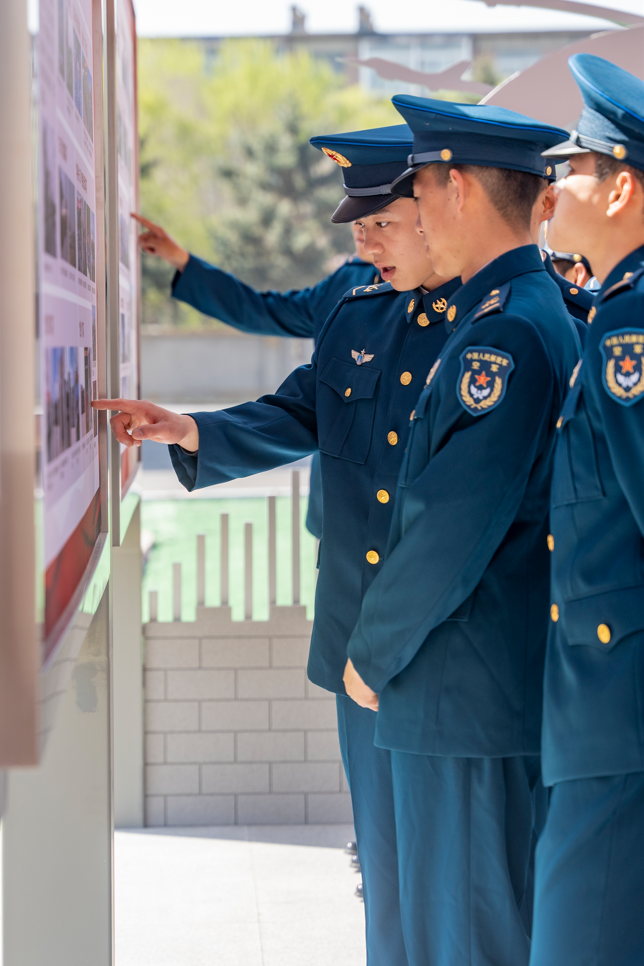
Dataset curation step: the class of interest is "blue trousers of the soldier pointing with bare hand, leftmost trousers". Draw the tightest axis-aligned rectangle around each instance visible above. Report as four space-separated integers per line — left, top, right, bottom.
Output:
337 695 408 966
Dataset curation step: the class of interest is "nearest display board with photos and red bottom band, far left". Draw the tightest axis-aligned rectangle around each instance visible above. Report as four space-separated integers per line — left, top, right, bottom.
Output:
36 0 105 661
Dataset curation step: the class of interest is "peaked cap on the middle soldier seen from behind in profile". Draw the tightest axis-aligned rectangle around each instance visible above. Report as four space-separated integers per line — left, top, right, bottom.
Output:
393 95 567 197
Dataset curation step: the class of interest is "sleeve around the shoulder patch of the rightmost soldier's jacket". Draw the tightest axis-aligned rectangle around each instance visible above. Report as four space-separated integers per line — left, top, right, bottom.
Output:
589 292 644 537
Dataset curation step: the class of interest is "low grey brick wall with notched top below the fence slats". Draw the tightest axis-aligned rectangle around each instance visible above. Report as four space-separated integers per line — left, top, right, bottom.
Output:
144 606 352 826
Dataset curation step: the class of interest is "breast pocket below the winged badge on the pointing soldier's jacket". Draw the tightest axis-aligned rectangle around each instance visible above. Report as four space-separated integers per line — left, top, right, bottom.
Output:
317 358 381 463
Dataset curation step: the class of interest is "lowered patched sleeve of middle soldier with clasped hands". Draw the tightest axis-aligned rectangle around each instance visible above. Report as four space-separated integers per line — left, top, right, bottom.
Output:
348 316 559 692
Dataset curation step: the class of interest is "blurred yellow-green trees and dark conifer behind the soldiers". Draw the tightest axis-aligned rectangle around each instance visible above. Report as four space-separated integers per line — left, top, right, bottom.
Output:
139 40 400 325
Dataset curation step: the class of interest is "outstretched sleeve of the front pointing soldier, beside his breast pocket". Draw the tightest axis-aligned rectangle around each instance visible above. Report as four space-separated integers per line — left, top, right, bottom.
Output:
169 362 318 490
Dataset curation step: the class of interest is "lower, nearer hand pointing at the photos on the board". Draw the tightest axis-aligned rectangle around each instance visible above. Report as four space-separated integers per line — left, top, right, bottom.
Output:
92 399 199 452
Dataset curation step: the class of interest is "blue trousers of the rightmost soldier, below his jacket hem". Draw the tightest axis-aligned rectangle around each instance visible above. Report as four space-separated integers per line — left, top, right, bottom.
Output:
530 772 644 966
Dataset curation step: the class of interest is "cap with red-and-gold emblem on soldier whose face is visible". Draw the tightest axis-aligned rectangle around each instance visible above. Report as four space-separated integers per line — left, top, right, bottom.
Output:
311 124 413 224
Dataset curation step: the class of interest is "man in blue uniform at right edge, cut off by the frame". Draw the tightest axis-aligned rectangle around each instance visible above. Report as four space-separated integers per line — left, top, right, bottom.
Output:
531 54 644 966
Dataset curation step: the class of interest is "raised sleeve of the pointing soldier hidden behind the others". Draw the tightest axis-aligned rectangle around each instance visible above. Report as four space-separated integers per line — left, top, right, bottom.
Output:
172 255 338 339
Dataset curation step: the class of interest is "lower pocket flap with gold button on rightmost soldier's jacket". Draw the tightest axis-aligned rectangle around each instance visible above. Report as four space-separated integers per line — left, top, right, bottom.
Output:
564 586 644 651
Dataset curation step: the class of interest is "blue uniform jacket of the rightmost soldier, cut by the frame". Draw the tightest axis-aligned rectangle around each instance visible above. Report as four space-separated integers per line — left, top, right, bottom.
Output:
543 246 644 784
